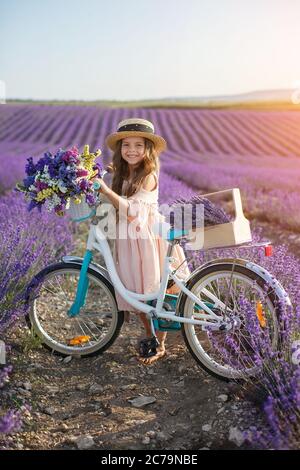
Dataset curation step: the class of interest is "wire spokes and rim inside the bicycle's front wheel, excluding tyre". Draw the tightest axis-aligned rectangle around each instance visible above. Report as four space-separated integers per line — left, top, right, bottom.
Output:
33 269 118 354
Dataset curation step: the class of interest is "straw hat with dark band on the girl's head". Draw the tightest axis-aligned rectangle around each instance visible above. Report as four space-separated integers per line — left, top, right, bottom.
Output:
105 118 167 153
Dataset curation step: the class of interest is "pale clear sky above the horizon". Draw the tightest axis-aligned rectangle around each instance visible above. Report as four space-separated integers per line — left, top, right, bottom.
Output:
0 0 300 100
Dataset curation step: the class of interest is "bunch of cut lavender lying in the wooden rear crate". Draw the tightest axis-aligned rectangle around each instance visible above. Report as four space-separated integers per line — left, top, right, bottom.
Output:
170 195 230 229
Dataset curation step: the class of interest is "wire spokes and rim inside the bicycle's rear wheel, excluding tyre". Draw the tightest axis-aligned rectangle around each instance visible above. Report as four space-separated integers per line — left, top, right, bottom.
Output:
185 269 276 377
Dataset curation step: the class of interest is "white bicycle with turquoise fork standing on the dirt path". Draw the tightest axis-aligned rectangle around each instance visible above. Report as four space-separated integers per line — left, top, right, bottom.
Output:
27 188 291 381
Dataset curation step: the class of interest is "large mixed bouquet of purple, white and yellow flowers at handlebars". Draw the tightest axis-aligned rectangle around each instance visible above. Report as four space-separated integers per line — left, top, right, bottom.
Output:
16 145 105 216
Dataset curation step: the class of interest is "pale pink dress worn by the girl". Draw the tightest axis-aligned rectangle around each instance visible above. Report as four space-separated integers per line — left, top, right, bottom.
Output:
113 175 190 312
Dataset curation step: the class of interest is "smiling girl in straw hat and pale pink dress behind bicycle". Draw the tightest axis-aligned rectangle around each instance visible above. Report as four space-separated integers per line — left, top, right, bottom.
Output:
96 118 189 364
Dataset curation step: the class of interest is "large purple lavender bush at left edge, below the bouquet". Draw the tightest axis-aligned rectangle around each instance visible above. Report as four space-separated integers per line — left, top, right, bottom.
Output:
0 193 72 336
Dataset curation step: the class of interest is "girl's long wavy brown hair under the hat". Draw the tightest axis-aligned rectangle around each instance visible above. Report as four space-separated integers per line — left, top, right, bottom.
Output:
110 138 159 197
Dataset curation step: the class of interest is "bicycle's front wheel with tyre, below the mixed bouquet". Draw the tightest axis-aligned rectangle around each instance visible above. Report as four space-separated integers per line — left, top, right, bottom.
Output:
27 263 124 356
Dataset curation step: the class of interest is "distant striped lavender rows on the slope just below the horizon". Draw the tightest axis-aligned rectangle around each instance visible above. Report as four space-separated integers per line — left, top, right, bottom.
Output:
0 105 300 156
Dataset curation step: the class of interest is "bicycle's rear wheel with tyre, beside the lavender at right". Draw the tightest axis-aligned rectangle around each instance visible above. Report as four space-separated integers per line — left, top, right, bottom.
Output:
179 262 279 381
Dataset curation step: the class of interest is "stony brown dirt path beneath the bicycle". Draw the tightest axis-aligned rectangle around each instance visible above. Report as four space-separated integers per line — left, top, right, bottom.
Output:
0 318 259 449
